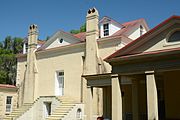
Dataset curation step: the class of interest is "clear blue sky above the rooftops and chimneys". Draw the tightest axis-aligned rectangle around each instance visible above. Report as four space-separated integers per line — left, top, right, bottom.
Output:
0 0 180 41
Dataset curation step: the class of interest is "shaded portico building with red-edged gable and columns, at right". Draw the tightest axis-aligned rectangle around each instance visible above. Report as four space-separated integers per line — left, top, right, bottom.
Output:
84 16 180 120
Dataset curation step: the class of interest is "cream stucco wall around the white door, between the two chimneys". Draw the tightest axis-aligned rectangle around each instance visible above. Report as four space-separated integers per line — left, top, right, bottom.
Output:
37 46 84 101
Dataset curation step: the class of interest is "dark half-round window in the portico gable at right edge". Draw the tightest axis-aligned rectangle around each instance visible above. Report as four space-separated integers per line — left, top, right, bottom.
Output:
167 30 180 42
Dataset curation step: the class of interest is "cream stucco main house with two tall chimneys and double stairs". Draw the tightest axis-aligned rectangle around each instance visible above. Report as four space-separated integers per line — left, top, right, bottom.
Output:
4 8 149 120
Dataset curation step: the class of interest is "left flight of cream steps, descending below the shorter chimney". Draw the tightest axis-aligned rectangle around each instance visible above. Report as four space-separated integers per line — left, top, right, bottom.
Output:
3 103 33 120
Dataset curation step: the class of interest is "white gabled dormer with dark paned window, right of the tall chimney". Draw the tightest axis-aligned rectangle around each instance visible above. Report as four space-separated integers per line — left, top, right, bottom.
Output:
99 17 123 38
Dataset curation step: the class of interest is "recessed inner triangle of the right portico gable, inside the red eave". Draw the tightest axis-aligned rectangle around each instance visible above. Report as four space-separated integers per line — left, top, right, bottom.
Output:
131 23 180 53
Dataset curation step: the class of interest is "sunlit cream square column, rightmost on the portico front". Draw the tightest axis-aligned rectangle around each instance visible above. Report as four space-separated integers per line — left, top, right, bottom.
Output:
145 71 158 120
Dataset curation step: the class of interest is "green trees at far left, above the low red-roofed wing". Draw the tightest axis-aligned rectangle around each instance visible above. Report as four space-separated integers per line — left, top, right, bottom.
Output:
0 36 23 84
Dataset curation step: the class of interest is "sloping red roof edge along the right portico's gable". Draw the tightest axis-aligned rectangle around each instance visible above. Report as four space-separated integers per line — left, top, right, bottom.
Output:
105 16 180 61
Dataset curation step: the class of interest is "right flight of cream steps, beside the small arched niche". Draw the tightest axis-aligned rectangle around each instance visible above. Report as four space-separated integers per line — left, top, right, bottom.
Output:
46 97 76 120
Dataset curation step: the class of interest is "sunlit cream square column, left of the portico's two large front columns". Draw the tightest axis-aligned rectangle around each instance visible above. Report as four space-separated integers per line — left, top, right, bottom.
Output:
111 74 122 120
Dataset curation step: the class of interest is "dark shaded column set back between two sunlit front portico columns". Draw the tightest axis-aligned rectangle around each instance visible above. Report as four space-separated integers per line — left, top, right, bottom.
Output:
132 79 139 120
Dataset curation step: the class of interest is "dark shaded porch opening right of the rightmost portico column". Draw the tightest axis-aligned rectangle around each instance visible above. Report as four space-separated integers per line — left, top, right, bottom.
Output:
155 70 180 120
